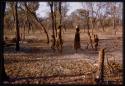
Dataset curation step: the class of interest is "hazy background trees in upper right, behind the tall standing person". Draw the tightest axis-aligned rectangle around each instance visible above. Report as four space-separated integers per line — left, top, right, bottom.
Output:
67 2 122 31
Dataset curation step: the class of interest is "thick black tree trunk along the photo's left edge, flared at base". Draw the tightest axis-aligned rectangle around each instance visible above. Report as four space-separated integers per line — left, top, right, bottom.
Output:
0 1 9 84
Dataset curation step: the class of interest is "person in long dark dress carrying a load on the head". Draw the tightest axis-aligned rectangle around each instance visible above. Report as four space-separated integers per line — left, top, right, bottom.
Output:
74 26 81 53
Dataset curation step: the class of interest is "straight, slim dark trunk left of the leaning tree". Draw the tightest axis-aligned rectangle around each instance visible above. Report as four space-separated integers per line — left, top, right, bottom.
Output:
15 2 20 51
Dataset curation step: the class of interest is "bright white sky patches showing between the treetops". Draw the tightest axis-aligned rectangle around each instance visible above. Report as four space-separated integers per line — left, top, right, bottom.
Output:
36 2 82 17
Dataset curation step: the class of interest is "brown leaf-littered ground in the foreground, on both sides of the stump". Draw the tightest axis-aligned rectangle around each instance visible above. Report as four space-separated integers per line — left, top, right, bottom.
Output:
5 54 123 84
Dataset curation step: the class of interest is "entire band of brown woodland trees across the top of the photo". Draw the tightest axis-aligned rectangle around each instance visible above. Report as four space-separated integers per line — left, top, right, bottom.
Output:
0 1 122 81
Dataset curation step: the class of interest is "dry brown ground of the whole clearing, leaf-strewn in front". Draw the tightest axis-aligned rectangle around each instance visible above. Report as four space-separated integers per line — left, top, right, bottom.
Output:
4 29 123 84
